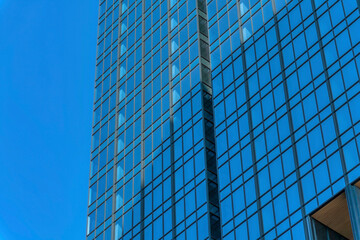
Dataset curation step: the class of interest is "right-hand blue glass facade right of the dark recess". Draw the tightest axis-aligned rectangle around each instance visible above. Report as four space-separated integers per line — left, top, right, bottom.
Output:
208 0 360 239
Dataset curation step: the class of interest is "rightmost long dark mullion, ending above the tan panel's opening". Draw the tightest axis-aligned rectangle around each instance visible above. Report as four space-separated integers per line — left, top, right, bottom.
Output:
311 0 349 185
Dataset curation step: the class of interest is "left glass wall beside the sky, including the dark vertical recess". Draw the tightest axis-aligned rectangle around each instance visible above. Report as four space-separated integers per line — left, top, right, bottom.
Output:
87 0 220 240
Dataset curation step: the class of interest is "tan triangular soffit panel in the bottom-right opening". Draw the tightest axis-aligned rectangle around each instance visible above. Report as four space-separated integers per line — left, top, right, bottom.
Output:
312 193 354 240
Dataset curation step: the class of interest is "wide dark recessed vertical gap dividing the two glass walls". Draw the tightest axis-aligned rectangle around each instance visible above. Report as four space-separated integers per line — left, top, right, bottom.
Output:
197 0 222 239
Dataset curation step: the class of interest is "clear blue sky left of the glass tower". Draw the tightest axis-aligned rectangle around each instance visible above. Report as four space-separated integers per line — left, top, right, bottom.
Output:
0 0 98 240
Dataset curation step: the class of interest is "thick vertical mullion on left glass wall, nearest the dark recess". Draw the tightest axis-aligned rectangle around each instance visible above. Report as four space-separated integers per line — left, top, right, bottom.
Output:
167 0 176 239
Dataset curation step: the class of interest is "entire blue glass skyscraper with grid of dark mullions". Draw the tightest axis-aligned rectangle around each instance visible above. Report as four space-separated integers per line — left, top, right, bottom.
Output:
87 0 360 240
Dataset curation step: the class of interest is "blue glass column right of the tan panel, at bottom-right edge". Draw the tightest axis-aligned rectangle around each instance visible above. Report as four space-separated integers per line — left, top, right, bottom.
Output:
345 185 360 240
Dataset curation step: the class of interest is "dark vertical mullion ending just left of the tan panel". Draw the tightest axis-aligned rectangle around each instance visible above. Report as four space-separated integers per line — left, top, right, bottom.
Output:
272 0 308 238
